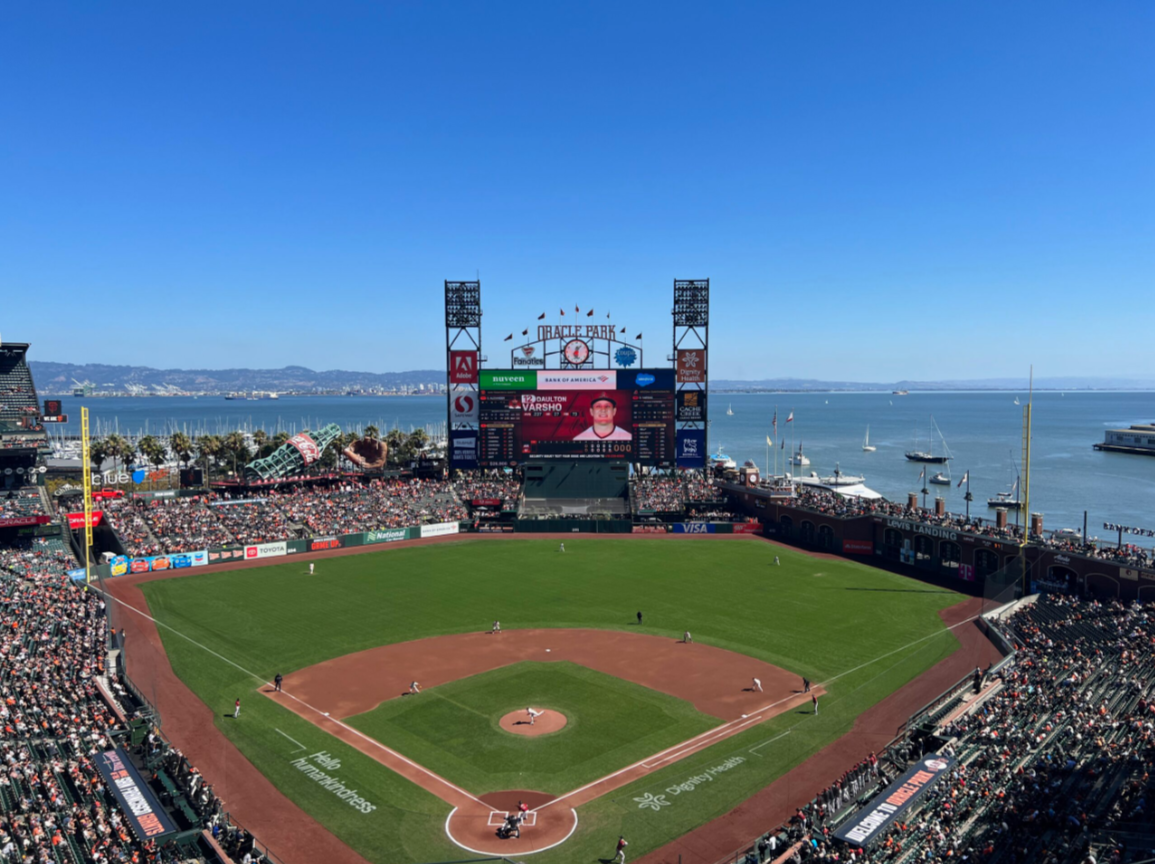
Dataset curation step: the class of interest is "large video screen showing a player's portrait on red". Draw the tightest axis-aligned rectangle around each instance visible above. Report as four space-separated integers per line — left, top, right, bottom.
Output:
477 370 677 468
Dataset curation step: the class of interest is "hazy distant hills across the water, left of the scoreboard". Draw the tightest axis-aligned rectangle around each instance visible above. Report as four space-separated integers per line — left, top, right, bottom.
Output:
28 360 445 393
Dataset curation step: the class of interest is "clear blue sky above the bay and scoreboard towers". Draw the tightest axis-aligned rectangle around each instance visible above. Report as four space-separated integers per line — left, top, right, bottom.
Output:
0 1 1155 381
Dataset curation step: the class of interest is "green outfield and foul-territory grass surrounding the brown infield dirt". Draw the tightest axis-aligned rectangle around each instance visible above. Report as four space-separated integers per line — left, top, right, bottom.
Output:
135 537 962 864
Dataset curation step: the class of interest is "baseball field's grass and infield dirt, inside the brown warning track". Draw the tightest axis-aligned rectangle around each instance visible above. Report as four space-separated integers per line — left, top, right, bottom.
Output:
129 536 963 864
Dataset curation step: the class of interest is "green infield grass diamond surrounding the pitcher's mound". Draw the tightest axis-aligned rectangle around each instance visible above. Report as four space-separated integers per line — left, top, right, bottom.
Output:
345 662 722 795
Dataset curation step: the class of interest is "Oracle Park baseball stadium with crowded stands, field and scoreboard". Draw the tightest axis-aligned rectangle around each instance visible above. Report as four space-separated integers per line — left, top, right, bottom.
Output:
0 280 1155 864
